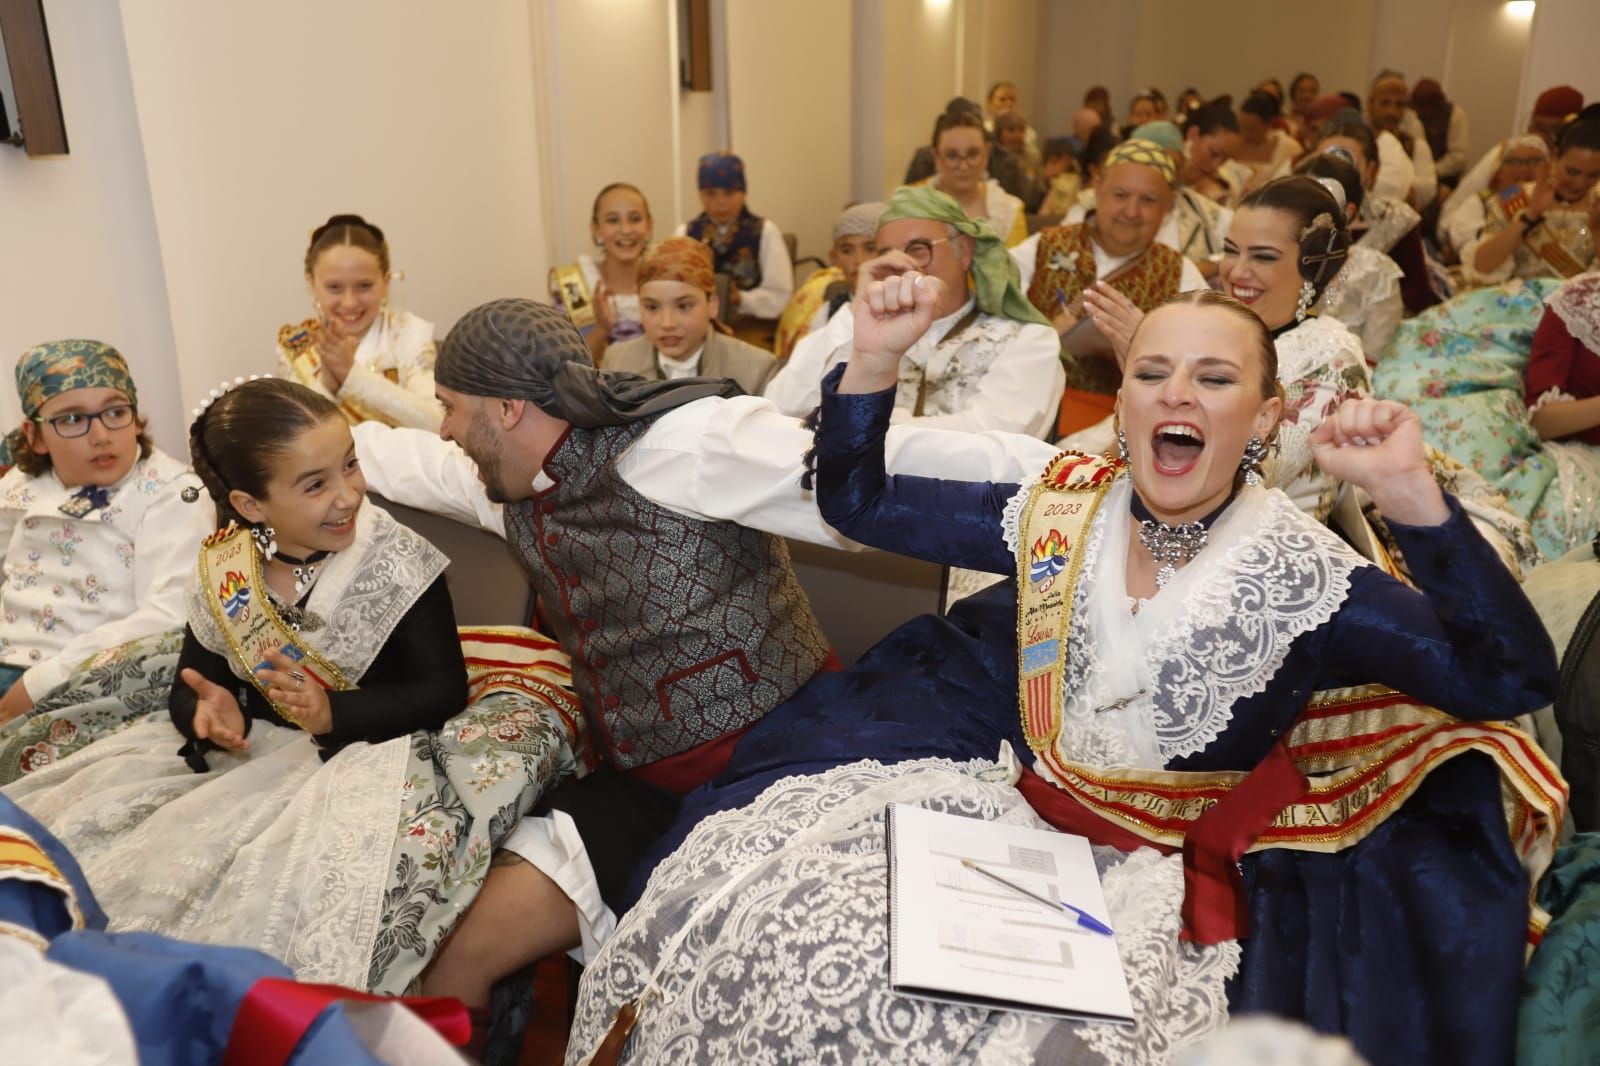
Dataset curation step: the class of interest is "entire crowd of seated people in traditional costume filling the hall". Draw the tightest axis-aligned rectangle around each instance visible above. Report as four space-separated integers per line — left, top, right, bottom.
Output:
9 70 1600 1064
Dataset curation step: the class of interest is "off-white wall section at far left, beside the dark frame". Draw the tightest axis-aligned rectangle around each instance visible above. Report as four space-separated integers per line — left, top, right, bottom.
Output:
0 0 187 456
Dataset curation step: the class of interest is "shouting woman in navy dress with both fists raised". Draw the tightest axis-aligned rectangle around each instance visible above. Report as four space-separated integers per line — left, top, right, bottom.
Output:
573 291 1565 1064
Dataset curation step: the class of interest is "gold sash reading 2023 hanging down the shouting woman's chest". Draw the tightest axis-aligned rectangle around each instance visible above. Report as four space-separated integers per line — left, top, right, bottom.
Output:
1016 451 1125 752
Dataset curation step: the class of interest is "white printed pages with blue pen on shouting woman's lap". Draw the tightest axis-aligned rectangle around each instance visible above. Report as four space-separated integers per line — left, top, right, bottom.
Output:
886 804 1133 1024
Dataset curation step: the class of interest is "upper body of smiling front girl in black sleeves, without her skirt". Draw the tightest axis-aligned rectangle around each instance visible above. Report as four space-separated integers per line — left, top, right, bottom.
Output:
171 378 467 758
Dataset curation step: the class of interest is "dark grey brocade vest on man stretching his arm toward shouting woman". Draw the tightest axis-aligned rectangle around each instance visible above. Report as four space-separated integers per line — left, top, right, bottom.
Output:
506 419 827 770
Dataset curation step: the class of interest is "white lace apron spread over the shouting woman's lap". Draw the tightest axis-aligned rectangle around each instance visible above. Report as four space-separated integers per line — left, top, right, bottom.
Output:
568 759 1238 1064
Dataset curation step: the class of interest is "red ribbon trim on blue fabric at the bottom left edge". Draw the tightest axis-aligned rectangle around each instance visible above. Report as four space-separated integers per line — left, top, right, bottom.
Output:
222 978 472 1066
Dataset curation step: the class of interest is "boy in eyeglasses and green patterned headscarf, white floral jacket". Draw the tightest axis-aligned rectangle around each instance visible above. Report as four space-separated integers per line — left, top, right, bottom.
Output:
0 339 211 723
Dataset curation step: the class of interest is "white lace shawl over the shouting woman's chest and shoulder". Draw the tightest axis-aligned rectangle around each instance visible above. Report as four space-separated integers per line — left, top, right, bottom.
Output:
1003 477 1368 770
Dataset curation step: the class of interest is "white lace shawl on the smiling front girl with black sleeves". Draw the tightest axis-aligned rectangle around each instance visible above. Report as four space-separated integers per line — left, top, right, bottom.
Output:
189 501 450 683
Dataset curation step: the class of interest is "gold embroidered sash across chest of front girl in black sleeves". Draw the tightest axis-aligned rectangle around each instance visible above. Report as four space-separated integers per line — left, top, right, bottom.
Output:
200 525 352 727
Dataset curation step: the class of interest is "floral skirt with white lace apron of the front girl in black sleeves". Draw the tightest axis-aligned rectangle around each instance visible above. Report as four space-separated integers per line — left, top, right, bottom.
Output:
0 634 581 994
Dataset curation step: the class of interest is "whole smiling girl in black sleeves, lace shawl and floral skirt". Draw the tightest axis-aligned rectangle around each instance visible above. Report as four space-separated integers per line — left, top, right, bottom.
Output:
6 378 578 992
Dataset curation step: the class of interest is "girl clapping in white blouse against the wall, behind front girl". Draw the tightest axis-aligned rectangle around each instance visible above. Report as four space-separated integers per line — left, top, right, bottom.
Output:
278 214 442 432
